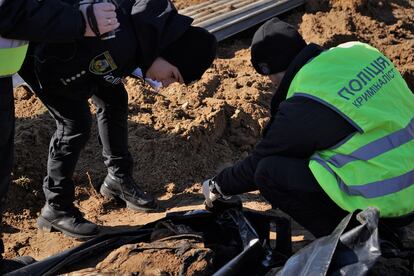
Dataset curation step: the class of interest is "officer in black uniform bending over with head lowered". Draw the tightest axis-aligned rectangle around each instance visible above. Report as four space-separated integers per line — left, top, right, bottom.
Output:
22 0 216 238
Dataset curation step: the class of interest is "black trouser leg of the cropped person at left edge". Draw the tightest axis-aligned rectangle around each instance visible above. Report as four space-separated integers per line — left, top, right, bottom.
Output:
0 77 15 259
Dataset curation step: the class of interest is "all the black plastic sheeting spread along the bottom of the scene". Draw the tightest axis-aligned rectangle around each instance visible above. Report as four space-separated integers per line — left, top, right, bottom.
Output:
8 204 414 276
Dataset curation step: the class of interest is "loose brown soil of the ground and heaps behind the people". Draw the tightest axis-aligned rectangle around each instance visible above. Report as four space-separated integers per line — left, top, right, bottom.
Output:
3 0 414 272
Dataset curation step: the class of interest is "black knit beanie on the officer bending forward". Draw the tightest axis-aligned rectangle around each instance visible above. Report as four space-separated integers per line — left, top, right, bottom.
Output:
161 27 217 84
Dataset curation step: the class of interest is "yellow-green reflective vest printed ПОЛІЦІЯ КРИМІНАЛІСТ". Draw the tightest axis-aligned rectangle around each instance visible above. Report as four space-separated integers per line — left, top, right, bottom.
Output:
288 42 414 217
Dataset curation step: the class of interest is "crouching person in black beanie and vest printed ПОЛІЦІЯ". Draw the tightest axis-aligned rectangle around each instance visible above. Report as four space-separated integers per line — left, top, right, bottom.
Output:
203 18 414 237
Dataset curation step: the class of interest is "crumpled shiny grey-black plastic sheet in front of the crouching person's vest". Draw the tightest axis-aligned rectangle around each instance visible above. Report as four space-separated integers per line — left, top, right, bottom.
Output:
269 208 381 276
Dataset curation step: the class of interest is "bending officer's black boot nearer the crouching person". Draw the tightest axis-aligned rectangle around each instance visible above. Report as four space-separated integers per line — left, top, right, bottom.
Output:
100 174 158 212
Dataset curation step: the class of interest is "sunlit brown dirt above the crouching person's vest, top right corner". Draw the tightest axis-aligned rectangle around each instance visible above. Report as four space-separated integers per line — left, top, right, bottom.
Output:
299 0 414 87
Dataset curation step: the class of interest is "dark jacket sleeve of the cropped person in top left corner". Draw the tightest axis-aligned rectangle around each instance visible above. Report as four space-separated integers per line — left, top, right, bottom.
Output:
0 0 85 42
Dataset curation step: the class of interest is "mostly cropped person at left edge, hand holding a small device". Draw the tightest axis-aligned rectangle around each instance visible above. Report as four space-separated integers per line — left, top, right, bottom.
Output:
0 0 119 274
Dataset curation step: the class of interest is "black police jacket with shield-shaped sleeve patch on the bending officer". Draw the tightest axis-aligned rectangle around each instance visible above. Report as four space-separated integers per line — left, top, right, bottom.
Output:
21 0 192 93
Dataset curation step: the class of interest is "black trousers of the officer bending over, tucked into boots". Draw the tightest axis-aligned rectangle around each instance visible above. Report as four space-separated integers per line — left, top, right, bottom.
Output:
37 84 133 210
